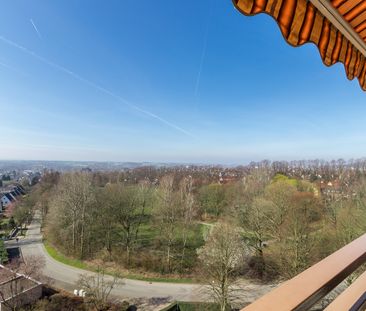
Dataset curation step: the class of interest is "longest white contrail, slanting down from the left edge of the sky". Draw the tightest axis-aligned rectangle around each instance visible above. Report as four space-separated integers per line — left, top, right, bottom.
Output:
0 36 195 138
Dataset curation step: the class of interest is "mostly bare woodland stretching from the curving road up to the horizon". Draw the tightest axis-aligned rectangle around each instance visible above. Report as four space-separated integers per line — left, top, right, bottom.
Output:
18 160 366 302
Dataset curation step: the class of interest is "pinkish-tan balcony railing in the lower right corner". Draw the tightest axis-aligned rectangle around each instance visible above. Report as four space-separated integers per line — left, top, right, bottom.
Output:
242 234 366 311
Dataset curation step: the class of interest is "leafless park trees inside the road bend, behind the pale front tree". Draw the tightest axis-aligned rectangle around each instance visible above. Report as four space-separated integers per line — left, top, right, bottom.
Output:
27 168 366 277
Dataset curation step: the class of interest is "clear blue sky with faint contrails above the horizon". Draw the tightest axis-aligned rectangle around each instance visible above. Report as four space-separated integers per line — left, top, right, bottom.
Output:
0 0 366 163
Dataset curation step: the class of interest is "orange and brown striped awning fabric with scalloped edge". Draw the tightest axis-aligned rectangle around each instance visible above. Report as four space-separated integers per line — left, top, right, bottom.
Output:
233 0 366 91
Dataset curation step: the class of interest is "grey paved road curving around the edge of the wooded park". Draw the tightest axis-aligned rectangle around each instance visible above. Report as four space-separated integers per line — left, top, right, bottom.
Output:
6 212 276 310
